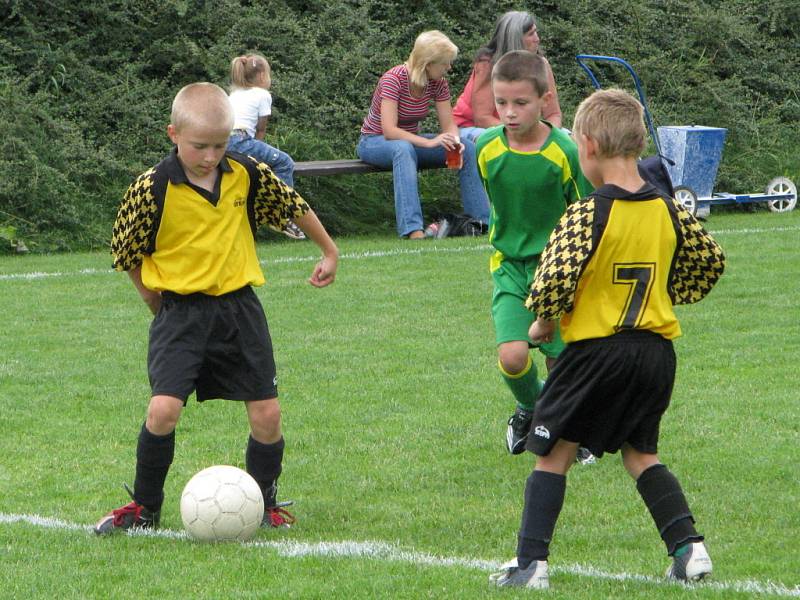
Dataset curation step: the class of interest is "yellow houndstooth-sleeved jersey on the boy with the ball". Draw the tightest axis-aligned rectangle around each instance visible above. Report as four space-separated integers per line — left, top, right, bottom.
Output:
111 150 309 296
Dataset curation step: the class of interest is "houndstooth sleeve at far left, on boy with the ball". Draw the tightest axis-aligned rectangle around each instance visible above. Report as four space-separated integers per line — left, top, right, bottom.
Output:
111 167 157 271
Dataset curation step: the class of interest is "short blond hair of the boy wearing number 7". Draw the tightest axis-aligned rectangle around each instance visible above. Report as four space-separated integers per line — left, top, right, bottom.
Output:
572 88 647 158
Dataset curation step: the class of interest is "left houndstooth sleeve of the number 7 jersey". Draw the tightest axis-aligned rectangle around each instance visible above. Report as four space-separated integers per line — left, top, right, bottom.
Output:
525 196 595 320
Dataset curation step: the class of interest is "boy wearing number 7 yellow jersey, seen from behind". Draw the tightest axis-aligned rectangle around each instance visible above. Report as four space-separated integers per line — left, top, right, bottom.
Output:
490 90 725 588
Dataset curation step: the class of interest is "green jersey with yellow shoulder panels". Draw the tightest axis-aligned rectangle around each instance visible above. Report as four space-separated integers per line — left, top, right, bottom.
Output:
476 123 592 270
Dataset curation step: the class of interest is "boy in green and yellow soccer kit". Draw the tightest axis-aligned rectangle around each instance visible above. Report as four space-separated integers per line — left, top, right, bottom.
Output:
477 50 592 454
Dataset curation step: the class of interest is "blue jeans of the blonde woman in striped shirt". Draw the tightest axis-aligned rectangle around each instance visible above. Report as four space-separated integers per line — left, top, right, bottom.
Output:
356 134 489 237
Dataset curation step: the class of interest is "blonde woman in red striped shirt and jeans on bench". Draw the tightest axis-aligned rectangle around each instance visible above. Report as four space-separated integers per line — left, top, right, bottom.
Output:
356 31 489 239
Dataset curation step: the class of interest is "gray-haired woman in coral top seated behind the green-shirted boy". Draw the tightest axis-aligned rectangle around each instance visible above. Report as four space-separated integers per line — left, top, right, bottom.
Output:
453 11 561 141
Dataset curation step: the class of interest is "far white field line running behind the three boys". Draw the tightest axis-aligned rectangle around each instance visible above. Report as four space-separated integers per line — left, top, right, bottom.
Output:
0 226 800 281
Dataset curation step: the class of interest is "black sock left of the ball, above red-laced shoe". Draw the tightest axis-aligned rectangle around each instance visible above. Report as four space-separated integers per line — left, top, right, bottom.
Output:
133 424 175 511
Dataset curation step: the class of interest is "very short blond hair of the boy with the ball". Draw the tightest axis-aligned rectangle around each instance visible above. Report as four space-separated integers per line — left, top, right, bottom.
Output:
170 81 233 131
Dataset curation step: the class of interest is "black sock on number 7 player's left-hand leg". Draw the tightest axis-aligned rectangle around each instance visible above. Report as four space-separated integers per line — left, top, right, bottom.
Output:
517 471 567 569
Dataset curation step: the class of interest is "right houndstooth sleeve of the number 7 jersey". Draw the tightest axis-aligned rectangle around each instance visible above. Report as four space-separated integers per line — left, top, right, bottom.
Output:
669 200 725 304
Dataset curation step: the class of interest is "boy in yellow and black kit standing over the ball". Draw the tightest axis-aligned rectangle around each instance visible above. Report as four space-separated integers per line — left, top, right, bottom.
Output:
95 83 338 535
